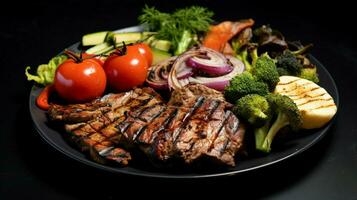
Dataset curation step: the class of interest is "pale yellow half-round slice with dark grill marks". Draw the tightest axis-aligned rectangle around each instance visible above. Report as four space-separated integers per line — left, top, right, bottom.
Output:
274 76 337 129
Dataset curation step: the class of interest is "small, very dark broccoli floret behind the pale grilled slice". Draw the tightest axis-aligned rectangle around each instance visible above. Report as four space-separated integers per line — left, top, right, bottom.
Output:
276 51 302 76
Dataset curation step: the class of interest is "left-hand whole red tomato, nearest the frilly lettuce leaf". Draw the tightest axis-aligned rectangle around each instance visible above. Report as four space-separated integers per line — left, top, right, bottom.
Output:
54 58 107 103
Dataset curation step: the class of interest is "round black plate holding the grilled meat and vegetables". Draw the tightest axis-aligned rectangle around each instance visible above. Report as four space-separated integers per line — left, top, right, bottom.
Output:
29 27 339 178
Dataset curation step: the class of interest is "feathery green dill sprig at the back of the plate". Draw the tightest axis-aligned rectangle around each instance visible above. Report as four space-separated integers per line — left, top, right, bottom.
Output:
138 6 213 55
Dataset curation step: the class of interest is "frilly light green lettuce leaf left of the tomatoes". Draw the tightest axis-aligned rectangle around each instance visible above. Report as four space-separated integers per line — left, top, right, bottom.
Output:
25 55 67 85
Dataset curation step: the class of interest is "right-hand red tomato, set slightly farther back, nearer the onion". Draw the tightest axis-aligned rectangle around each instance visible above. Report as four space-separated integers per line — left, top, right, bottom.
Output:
104 46 149 91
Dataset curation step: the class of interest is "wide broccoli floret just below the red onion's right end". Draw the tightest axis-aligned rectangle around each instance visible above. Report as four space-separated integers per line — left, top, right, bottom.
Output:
224 72 269 103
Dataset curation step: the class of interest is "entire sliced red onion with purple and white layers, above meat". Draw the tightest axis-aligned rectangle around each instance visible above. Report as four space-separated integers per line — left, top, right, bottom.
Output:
167 47 245 91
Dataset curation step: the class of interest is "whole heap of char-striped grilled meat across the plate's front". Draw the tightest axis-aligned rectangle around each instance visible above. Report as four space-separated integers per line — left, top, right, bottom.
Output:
49 85 244 166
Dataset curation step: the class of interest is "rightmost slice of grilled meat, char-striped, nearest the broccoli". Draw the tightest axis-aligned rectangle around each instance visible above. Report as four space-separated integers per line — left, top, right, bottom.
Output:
173 98 245 166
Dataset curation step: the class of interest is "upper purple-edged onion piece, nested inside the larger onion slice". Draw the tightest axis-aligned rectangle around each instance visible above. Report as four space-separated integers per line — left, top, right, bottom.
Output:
186 47 233 76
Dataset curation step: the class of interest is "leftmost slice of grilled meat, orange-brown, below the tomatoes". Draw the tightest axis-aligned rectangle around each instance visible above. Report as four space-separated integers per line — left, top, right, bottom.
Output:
48 88 162 165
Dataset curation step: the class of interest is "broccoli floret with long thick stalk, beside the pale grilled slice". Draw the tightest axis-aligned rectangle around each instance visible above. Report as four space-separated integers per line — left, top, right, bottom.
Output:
255 94 302 152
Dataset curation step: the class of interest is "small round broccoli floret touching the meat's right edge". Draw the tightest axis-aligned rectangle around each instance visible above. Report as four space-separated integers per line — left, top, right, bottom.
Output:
233 94 270 127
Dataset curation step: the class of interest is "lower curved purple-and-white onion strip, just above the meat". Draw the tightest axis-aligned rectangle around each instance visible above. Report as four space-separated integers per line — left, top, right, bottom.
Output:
189 63 244 91
